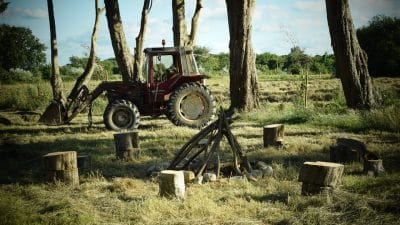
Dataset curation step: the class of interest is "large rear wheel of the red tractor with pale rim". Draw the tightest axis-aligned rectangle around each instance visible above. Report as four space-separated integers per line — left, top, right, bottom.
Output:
167 83 215 127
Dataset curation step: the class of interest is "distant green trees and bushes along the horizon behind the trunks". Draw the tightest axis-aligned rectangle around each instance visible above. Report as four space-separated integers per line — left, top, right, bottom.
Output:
0 16 400 83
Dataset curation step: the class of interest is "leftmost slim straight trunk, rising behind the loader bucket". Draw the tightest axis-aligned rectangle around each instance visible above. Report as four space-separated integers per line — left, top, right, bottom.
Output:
47 0 65 106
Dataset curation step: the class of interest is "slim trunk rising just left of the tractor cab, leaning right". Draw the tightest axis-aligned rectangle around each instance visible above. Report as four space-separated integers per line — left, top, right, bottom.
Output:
133 0 152 79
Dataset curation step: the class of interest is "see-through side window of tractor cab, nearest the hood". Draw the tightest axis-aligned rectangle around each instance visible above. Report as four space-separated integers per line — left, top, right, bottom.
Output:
153 55 176 83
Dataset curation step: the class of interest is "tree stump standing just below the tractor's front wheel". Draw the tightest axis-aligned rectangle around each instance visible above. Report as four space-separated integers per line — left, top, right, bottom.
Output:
114 131 140 160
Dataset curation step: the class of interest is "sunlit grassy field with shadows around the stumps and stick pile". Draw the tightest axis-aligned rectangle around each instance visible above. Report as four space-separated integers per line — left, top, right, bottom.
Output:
0 76 400 225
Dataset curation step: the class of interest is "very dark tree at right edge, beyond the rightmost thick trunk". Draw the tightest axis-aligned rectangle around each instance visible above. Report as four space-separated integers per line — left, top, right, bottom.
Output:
357 16 400 76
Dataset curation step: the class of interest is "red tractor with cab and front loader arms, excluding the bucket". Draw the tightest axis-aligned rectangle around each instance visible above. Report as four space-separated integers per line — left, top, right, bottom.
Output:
68 47 216 130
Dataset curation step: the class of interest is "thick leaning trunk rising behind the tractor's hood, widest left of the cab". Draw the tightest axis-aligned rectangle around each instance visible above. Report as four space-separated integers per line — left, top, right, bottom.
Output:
104 0 137 83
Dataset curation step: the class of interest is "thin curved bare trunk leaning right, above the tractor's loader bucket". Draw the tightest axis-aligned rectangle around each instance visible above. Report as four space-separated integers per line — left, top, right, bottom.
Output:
68 0 104 101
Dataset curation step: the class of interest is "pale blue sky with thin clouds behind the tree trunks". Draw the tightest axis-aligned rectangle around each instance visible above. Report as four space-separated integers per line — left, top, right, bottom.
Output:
0 0 400 65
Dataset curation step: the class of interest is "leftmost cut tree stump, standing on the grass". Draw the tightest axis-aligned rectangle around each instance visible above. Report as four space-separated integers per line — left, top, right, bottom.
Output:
43 151 79 185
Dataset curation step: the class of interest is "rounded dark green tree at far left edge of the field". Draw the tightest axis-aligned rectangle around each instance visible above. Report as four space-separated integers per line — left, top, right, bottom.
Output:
0 24 46 71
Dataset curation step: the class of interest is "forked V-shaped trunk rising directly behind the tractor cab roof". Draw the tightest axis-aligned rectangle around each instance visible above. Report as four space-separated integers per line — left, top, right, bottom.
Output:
172 0 203 47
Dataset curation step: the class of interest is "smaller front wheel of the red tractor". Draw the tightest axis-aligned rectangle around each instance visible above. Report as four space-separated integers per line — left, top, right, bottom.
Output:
103 100 140 131
